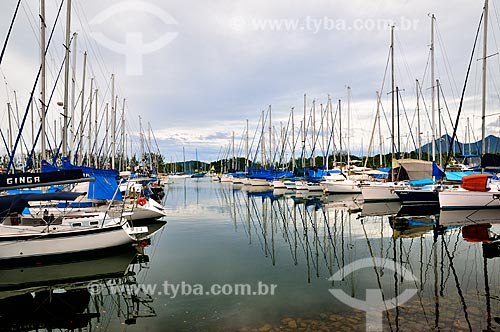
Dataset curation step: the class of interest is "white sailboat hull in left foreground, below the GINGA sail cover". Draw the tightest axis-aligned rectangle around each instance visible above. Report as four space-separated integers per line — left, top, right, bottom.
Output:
0 171 164 264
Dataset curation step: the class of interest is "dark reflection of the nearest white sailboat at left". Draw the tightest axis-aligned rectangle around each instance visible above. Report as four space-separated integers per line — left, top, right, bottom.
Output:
0 221 165 331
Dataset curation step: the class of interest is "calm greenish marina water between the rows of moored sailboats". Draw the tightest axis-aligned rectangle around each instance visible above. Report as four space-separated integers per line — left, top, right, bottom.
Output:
0 179 500 331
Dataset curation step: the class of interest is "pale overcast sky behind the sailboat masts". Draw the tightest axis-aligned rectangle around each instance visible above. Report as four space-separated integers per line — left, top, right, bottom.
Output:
0 0 500 161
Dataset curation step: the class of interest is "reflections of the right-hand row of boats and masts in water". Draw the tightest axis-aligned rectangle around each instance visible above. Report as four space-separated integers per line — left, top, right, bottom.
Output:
211 185 500 331
